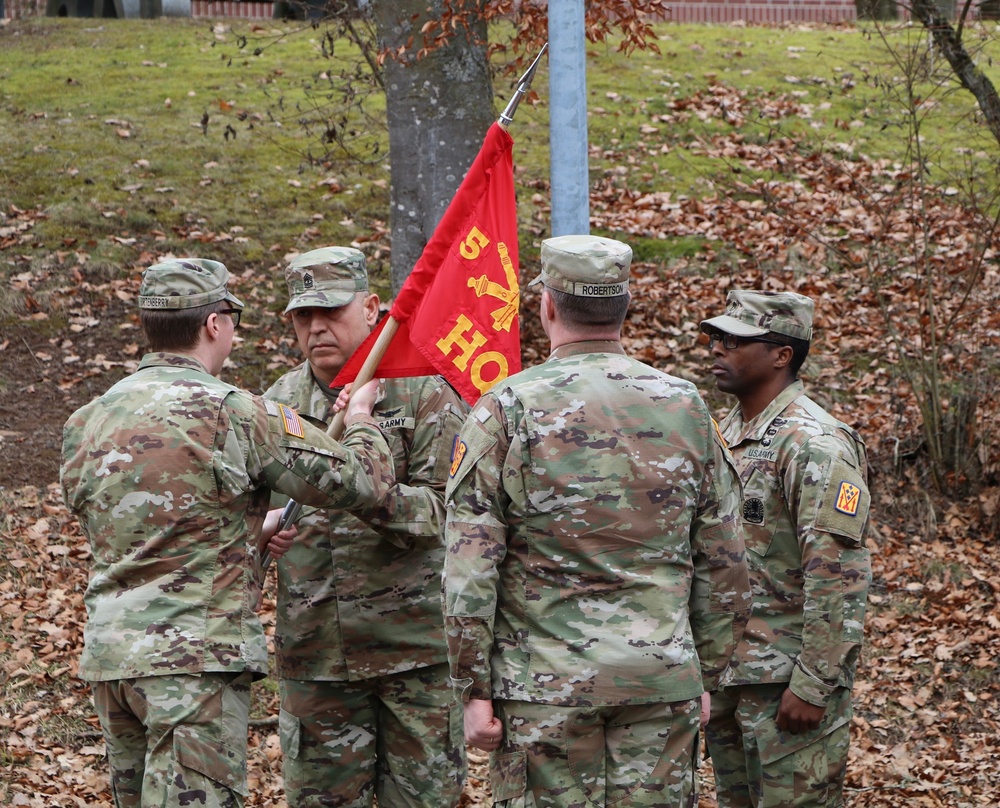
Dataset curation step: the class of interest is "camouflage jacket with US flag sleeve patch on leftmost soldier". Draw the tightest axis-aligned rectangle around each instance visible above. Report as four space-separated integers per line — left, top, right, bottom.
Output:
61 353 394 681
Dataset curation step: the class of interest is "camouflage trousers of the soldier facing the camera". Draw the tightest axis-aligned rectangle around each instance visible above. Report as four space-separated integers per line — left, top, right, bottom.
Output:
279 664 465 808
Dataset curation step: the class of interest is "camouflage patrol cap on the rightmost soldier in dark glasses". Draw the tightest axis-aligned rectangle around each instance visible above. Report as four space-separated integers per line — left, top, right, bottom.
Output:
701 289 815 342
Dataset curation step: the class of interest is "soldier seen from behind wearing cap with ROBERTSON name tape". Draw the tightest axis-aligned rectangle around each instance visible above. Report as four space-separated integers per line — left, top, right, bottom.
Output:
444 236 750 808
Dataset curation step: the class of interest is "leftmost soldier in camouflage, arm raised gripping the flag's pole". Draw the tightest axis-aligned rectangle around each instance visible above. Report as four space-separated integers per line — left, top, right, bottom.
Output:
61 259 395 808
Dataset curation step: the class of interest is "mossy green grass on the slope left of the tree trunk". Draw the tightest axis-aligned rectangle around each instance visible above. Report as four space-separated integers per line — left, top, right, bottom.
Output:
0 18 396 288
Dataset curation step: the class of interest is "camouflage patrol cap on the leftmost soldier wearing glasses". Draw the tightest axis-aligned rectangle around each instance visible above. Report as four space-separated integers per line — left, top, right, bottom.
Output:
139 258 243 310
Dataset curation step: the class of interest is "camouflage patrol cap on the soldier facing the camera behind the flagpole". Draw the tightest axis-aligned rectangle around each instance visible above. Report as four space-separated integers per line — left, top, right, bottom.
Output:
285 247 368 314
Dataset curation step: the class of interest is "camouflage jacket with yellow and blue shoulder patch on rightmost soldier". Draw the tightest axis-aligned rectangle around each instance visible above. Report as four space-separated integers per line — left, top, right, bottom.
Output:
720 382 871 705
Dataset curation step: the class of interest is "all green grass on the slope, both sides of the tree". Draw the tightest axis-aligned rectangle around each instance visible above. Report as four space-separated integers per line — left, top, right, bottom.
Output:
0 18 1000 263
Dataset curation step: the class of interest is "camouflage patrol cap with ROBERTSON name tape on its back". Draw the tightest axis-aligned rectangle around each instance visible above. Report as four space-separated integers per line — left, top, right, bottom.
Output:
528 236 632 297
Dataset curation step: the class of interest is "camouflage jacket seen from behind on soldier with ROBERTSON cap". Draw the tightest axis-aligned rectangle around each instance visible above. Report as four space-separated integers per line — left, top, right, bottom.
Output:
444 341 750 706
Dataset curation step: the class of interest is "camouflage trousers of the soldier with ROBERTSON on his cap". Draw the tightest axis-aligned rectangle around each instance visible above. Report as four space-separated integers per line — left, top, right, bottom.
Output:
490 699 700 808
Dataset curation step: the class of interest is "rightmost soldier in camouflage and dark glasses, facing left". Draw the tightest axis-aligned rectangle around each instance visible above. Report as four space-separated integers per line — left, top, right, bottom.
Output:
701 291 871 808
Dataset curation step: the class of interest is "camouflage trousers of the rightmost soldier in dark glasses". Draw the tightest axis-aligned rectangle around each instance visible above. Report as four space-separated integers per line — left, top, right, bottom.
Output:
705 683 853 808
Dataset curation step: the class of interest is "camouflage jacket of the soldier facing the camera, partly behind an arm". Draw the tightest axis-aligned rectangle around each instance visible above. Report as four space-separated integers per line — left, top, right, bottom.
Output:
264 363 468 681
